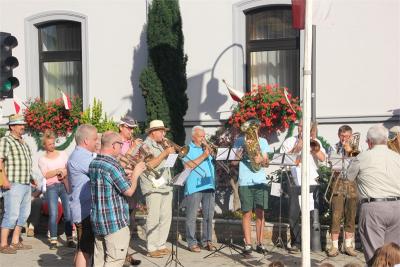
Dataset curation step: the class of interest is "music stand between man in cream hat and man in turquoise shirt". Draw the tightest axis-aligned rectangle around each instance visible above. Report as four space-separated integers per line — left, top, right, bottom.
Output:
164 169 192 267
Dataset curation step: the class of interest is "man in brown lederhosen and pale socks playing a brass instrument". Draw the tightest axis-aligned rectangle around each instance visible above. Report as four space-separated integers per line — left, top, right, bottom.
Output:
327 125 357 257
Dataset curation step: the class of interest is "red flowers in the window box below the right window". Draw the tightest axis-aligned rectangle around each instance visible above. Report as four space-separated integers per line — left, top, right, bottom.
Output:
229 85 301 133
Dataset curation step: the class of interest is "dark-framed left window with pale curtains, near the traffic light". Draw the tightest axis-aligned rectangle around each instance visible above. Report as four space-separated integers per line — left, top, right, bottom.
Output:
37 20 83 101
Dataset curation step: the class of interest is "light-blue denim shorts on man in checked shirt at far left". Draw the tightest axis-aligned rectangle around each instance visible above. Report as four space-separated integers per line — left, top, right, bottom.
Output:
1 183 31 229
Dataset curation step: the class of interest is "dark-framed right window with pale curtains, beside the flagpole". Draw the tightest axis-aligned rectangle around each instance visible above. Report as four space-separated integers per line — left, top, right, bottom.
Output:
245 6 300 96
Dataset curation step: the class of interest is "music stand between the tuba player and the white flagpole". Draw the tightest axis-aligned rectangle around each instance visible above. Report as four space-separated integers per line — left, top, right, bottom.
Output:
269 153 297 248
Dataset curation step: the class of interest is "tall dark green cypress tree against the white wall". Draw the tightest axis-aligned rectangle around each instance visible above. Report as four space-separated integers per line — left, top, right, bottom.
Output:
141 0 188 145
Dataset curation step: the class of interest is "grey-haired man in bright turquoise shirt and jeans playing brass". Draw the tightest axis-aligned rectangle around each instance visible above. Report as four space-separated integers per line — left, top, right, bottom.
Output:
183 126 215 252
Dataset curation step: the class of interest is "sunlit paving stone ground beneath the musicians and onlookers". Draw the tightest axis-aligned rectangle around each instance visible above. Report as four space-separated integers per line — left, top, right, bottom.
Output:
0 236 365 267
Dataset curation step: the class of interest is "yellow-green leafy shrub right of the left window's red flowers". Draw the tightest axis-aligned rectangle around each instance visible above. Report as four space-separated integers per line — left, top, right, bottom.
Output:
81 98 118 133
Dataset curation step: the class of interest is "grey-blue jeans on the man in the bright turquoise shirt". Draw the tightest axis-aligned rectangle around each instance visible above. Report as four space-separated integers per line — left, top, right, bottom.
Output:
186 190 215 247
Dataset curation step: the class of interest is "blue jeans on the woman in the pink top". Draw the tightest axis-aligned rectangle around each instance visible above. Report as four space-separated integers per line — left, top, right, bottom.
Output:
46 183 72 239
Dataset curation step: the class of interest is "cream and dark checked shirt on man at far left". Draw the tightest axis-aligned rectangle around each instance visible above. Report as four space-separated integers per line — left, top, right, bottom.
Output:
0 134 32 184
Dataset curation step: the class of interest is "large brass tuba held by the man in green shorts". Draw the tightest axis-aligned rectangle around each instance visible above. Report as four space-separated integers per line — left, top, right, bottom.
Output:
240 119 263 172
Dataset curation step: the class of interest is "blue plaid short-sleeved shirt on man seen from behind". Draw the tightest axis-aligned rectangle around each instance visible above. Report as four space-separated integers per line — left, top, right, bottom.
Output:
89 155 130 236
